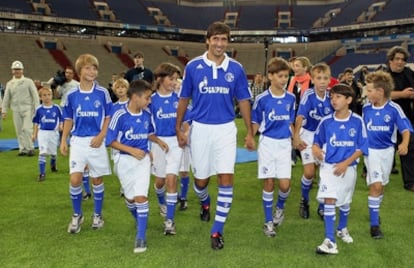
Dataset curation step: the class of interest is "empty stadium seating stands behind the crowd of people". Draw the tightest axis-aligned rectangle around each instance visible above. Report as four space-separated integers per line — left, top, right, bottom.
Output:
0 0 414 86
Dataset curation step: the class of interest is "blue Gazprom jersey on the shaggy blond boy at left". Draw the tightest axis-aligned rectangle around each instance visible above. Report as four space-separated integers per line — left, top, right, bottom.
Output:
63 83 112 137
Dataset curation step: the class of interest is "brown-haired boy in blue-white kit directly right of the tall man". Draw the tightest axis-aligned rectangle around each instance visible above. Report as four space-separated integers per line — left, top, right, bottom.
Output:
252 57 296 237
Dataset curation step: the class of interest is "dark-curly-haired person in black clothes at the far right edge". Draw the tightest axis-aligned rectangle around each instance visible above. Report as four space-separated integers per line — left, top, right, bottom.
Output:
387 46 414 192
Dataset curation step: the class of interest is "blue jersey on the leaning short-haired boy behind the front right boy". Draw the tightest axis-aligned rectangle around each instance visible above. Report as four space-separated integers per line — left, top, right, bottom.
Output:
296 88 333 132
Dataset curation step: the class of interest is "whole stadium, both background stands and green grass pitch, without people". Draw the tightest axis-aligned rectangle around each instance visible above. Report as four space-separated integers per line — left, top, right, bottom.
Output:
0 0 414 267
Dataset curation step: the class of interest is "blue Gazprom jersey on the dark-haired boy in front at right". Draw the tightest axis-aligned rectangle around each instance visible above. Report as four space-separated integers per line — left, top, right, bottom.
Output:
314 112 368 165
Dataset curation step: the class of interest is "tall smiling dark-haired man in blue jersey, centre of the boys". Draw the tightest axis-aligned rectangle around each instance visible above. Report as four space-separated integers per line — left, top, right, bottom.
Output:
175 22 255 249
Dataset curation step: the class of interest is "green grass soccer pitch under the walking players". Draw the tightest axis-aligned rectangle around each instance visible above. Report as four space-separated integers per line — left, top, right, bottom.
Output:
0 118 414 267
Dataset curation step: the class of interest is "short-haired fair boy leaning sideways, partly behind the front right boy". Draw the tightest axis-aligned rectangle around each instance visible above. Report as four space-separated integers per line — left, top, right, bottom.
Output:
293 63 333 219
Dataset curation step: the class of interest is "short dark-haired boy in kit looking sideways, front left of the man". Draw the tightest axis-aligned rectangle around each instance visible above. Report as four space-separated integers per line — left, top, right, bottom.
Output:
107 80 155 253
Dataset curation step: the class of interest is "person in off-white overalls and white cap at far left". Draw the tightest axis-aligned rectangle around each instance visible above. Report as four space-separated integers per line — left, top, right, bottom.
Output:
1 60 40 156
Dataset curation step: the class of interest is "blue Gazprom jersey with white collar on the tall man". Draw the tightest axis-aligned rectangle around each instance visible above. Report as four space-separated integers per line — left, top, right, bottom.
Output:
179 52 252 124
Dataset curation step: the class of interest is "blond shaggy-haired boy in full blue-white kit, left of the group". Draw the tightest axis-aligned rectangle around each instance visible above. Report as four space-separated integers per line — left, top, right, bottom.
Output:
60 54 112 234
